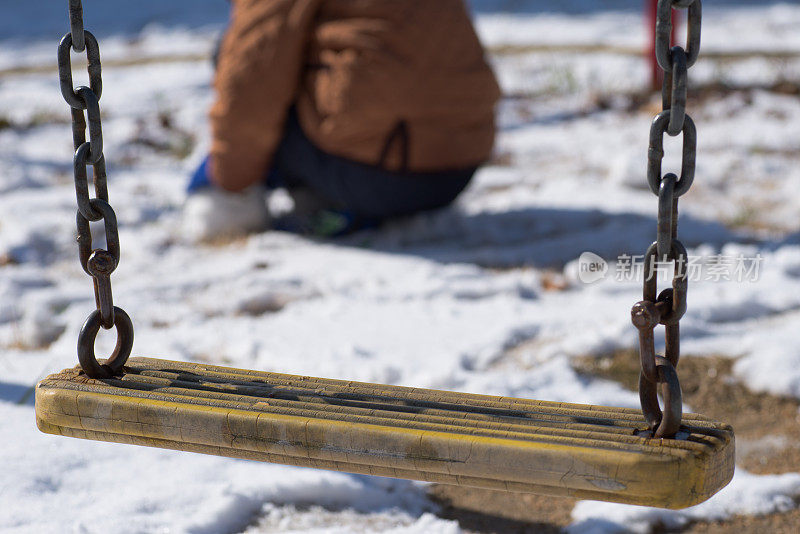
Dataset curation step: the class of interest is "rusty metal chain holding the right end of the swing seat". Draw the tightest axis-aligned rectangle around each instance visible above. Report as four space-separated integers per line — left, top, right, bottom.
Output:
631 0 703 438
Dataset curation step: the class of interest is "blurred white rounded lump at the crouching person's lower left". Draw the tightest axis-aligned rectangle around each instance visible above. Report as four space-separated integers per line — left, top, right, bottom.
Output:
181 186 270 243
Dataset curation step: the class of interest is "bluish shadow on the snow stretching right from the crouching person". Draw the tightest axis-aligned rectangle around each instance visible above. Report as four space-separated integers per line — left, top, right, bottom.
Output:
337 207 753 269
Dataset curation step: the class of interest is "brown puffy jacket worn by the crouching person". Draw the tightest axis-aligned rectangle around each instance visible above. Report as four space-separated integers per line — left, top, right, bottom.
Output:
210 0 499 191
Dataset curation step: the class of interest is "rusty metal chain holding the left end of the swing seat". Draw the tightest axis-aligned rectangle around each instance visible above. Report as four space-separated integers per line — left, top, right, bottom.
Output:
58 0 133 384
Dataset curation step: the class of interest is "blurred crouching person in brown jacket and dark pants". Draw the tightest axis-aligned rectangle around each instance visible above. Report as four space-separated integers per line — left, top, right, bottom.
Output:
184 0 500 240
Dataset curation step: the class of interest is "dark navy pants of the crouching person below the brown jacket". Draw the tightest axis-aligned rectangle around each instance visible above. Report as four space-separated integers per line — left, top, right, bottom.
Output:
267 113 476 219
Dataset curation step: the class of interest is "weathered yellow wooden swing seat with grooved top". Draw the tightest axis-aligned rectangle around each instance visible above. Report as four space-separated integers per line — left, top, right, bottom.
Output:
36 358 734 508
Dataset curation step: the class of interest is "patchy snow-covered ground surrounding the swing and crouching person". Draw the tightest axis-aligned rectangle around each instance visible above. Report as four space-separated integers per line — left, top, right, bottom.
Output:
0 0 800 533
